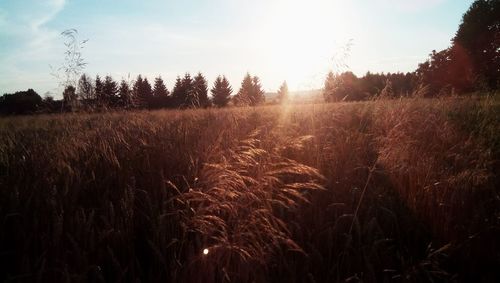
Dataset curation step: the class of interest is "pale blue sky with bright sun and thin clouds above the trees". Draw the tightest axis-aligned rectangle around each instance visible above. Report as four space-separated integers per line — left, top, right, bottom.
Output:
0 0 472 98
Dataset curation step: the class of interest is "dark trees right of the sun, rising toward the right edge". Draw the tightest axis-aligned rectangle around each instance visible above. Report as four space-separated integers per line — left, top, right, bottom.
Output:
323 0 500 101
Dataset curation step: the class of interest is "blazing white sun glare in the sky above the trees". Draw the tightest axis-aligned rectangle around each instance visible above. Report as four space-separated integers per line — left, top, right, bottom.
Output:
261 0 353 88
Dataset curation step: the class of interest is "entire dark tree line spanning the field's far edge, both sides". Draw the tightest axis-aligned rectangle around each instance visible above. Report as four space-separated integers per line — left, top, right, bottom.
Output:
0 0 500 114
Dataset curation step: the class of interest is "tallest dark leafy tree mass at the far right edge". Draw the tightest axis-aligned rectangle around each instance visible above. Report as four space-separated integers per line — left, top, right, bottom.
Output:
416 0 500 94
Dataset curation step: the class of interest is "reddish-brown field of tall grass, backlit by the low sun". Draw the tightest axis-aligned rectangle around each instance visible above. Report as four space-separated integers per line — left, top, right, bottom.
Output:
0 98 500 282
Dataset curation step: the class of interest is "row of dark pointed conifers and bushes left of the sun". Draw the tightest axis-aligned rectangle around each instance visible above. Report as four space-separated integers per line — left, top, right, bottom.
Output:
0 73 272 114
